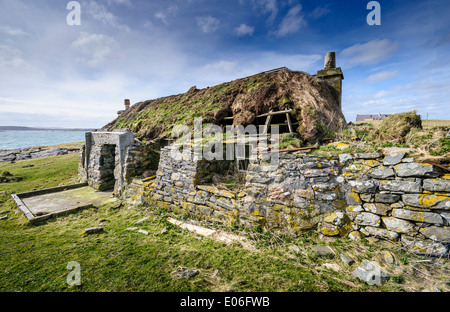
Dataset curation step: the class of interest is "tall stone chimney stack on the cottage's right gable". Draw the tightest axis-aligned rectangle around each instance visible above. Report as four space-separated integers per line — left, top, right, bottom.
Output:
316 52 344 111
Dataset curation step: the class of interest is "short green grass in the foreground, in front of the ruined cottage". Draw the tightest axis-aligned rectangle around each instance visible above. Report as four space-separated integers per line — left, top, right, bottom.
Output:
0 154 450 292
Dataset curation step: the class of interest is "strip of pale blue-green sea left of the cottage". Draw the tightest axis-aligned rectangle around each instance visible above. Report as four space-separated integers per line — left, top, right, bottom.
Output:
0 130 86 150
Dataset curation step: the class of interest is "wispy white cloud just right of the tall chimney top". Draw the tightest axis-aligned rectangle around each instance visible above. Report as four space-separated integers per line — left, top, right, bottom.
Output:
340 39 400 66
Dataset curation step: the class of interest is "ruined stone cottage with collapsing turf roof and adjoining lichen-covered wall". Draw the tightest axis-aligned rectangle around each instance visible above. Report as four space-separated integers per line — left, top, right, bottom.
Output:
79 53 450 255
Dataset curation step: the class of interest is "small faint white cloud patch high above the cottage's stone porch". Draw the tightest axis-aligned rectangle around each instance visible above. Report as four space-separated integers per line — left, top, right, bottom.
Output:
72 32 118 67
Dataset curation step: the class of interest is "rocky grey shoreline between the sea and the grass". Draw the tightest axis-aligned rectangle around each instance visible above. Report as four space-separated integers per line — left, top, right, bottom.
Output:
0 147 79 162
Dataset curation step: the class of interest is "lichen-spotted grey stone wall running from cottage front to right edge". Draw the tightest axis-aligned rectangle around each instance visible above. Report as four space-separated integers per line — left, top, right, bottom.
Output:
146 146 450 255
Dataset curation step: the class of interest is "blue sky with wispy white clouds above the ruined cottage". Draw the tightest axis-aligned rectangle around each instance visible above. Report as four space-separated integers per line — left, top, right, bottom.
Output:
0 0 450 128
